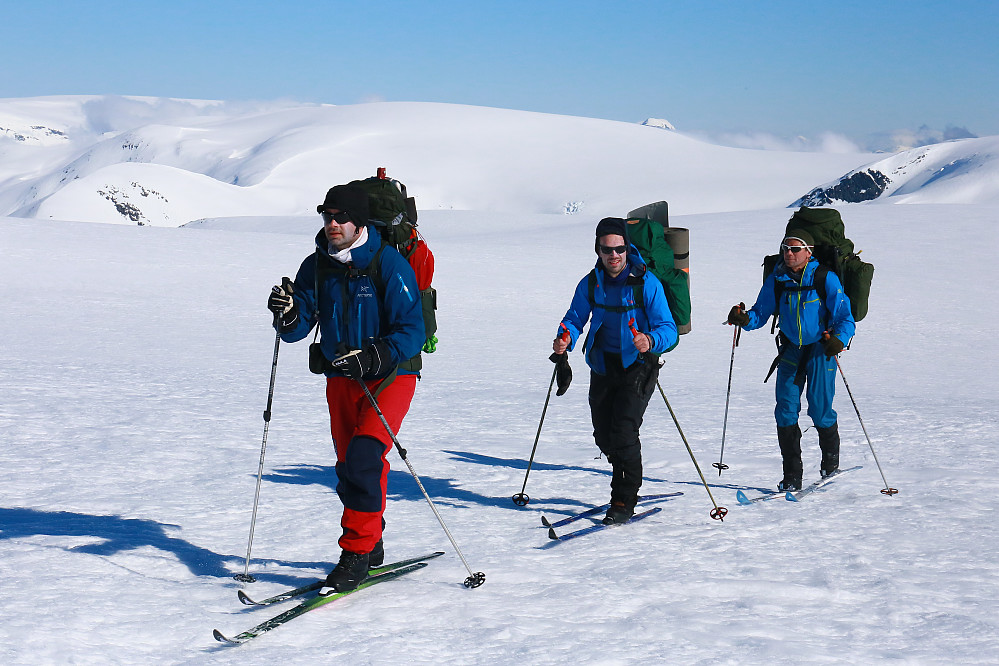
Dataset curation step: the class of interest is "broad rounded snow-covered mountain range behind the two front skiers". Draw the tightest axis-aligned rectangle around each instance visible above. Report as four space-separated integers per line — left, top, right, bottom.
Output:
0 97 884 226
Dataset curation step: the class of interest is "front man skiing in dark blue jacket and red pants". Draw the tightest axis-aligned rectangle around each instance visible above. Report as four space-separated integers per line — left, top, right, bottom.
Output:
267 185 426 593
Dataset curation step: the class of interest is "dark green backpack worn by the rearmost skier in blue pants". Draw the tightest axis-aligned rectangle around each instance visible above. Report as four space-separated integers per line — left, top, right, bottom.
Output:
763 206 874 321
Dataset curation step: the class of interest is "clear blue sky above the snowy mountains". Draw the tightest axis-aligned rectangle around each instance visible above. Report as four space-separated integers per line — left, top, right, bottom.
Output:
0 0 999 143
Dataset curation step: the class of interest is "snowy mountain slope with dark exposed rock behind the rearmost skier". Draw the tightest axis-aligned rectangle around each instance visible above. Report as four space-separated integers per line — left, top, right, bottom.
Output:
794 136 999 206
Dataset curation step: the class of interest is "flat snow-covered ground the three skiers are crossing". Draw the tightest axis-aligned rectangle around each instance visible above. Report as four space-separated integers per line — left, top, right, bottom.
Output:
0 204 999 664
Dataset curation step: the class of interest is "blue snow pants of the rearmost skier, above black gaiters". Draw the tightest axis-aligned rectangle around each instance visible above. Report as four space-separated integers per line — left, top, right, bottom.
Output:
774 342 836 428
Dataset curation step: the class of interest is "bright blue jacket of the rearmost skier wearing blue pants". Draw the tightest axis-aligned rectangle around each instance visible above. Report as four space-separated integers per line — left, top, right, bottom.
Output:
743 257 857 348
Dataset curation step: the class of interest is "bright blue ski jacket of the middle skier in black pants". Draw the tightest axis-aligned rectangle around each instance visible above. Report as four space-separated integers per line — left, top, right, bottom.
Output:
556 245 677 375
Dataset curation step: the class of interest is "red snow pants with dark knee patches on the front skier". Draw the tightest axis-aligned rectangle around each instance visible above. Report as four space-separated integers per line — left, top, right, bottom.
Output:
326 375 416 553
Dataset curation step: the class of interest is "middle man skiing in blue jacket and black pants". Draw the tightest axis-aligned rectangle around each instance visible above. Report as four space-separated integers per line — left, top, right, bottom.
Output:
552 217 677 524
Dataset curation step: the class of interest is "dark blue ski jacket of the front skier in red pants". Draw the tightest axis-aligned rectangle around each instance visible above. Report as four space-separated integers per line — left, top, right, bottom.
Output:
281 229 426 377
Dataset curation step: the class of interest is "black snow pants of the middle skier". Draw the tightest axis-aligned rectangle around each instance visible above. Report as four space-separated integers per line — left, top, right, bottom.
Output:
589 354 659 508
